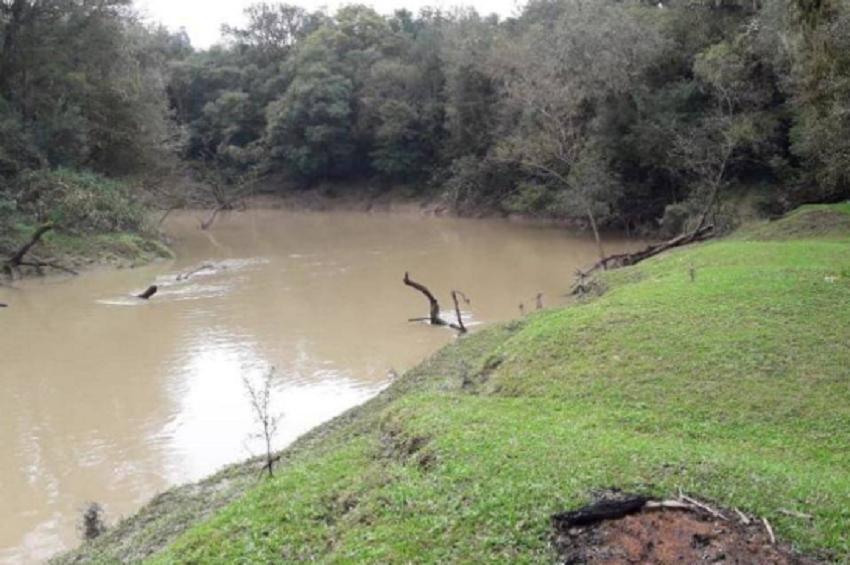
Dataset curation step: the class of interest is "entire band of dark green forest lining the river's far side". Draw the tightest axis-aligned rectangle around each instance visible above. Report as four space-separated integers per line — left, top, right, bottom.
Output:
0 0 850 252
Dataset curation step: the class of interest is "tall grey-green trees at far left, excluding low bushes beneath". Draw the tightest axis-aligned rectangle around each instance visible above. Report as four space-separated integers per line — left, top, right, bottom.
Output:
0 0 180 176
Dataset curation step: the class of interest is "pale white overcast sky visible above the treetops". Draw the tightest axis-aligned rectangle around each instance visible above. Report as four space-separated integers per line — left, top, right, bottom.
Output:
136 0 517 48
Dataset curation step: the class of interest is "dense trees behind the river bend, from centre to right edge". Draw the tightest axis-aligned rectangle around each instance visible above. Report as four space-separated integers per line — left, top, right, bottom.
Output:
170 0 850 232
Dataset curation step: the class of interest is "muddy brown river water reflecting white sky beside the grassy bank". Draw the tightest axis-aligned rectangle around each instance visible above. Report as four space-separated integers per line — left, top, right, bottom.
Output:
0 210 643 564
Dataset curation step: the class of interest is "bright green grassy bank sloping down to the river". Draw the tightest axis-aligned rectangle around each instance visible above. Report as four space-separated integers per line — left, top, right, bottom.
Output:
57 206 850 564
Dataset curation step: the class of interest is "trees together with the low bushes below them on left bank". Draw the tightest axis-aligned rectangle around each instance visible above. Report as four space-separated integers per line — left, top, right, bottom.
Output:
0 0 190 262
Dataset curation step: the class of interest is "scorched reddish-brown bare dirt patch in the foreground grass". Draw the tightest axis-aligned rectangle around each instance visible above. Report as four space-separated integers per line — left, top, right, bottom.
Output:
553 500 816 565
